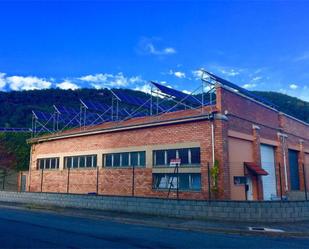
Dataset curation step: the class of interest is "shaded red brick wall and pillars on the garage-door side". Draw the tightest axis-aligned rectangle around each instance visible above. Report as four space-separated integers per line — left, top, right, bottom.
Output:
217 87 309 198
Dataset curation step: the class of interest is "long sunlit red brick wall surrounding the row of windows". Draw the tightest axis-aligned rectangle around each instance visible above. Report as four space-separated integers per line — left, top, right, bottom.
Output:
30 121 211 199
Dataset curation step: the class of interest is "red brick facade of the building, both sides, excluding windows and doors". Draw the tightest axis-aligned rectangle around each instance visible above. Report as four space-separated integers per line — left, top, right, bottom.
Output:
28 86 309 200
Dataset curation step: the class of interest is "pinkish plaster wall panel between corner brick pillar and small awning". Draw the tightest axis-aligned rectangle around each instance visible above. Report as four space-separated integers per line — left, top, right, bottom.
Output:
229 138 253 200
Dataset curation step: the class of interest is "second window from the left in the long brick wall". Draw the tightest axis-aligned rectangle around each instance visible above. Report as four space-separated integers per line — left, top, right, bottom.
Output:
64 155 97 168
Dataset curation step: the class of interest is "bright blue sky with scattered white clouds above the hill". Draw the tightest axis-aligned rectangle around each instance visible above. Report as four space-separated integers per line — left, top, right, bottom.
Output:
0 0 309 101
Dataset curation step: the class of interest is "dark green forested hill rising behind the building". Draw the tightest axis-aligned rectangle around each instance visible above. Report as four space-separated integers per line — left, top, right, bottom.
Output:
0 89 309 128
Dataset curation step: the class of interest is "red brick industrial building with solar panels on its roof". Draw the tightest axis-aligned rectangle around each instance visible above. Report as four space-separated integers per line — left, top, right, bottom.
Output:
23 72 309 200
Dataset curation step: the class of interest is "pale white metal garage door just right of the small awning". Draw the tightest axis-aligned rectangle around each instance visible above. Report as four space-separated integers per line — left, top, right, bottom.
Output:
261 144 277 200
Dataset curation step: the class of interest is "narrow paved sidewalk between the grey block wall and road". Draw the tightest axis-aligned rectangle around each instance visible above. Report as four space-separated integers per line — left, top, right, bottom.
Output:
0 202 309 238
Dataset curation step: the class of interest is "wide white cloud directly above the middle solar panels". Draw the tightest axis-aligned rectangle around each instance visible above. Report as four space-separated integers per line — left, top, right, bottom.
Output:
78 72 144 89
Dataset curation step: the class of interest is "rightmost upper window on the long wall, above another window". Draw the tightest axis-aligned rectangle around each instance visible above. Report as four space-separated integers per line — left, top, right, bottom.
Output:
153 147 201 166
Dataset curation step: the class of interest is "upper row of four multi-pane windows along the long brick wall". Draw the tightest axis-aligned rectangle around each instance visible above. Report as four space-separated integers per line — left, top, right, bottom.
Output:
38 147 200 169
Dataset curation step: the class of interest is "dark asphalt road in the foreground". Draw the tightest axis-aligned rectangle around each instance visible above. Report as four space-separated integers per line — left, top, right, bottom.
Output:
0 208 309 249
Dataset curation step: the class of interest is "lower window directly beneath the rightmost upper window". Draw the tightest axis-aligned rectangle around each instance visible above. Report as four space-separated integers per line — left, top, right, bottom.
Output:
152 173 201 191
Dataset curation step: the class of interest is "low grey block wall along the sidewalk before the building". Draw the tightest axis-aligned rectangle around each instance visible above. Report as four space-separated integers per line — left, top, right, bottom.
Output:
0 191 309 222
